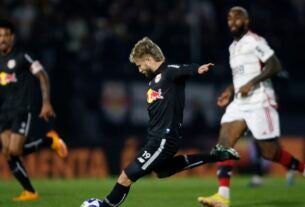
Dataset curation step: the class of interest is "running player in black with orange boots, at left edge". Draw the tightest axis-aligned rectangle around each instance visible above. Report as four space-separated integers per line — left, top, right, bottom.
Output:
0 19 67 201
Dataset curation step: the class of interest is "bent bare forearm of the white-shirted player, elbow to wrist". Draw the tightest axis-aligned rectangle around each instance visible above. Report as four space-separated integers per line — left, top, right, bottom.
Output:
250 55 282 85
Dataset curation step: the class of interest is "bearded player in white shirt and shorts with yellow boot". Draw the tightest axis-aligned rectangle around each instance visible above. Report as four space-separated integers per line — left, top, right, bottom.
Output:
198 7 305 207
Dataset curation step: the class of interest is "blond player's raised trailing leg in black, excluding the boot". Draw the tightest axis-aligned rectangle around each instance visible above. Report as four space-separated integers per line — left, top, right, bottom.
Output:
157 154 218 178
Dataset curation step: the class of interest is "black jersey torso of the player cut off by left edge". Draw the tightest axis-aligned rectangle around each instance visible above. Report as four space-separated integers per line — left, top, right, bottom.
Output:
0 50 35 113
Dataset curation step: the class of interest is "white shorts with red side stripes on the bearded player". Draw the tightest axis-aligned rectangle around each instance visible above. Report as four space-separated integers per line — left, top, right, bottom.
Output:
221 101 280 140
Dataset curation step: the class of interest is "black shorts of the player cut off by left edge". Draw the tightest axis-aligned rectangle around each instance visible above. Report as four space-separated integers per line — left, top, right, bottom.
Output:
0 111 32 136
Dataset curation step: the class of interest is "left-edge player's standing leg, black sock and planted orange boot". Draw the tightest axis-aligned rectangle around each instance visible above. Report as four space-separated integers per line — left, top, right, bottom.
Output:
8 132 38 201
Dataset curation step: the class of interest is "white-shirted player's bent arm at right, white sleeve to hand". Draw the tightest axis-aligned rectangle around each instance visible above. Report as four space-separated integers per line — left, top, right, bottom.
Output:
239 41 282 96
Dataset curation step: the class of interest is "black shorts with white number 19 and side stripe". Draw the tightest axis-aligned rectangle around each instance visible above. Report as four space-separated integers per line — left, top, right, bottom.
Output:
124 137 181 182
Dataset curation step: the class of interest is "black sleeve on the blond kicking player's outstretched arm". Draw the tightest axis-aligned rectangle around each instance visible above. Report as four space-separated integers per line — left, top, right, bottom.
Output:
167 64 199 80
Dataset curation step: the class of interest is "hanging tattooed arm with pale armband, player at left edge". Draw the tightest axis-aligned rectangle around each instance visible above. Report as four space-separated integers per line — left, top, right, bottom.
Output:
25 54 56 121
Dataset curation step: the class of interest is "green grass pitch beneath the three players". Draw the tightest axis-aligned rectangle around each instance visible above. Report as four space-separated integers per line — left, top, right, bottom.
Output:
0 176 305 207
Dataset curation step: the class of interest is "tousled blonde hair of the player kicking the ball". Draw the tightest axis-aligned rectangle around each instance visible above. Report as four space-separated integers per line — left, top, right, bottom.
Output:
129 37 165 63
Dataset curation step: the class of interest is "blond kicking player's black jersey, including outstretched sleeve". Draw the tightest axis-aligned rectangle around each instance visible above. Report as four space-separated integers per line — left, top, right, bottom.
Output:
147 63 199 138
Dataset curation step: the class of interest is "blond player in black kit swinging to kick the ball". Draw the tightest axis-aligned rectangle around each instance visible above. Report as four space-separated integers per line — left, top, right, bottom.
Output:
96 37 239 207
